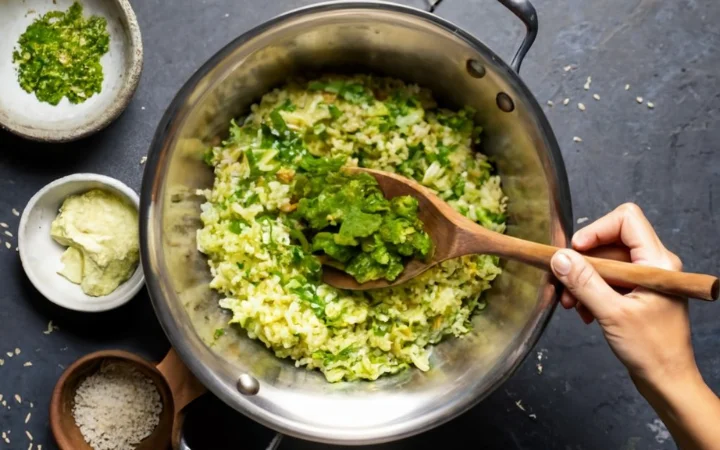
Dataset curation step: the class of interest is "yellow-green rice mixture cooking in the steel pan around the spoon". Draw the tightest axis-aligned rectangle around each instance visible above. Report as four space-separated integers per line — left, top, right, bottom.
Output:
197 75 506 382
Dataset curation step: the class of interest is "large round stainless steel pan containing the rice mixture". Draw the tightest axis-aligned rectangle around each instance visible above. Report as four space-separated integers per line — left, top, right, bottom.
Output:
141 0 572 444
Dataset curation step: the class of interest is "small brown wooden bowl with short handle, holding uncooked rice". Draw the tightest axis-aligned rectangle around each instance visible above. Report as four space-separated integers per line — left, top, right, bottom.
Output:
50 348 206 450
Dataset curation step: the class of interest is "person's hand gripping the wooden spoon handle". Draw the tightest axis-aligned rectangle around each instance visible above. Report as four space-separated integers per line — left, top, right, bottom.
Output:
552 203 699 387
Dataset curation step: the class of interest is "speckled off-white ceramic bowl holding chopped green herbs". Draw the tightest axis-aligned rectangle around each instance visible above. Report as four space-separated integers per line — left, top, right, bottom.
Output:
0 0 143 142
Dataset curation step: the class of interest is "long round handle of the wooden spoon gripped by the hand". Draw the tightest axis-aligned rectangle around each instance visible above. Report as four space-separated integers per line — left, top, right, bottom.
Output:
478 235 720 301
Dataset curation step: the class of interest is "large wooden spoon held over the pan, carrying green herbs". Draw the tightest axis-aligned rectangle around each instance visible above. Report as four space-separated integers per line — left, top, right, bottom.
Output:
323 167 720 301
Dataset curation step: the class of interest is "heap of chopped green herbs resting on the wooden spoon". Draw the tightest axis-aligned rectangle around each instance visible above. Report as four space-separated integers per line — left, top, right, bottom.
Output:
295 172 432 283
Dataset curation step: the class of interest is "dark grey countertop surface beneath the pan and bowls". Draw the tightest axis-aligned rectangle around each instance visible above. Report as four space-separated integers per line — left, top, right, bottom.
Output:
0 0 720 450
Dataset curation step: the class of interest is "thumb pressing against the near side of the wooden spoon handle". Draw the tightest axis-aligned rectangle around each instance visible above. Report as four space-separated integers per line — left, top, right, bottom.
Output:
550 250 620 320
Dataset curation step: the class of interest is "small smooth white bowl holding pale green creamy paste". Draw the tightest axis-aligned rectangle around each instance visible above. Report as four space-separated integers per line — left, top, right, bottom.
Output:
18 173 145 312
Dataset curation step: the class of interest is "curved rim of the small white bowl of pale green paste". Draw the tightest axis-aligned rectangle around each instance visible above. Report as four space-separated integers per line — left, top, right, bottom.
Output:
18 173 145 312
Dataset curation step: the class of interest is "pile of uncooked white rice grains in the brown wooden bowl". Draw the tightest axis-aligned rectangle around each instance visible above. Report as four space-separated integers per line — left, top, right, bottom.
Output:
73 362 162 450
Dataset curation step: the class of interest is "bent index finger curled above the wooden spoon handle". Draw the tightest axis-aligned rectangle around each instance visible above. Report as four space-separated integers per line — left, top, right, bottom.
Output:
572 203 666 262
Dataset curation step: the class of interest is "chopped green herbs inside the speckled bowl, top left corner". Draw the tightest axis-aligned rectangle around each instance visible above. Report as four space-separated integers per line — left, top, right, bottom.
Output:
13 2 110 105
